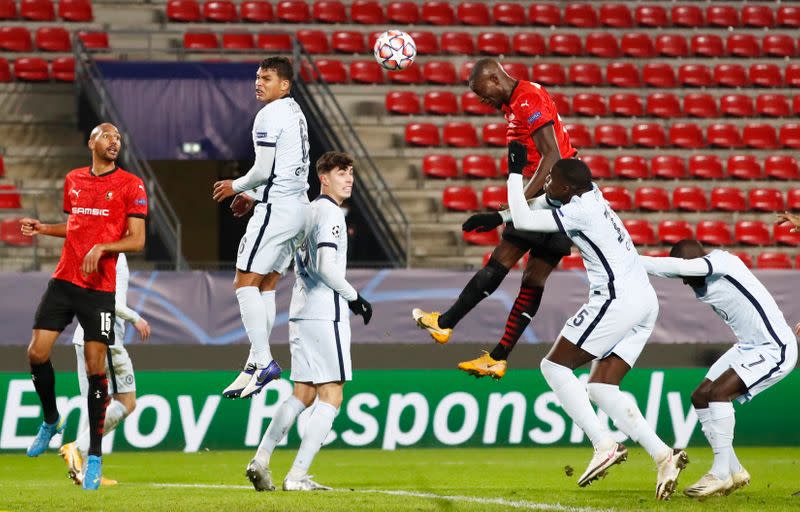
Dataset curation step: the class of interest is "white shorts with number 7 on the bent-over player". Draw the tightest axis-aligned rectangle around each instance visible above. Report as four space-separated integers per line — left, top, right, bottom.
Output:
706 340 797 403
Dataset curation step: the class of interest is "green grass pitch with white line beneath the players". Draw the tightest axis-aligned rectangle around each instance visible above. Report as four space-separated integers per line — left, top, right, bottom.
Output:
0 448 800 512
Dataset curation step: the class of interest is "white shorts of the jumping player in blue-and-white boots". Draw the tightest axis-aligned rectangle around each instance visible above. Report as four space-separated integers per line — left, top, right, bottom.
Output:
236 199 310 275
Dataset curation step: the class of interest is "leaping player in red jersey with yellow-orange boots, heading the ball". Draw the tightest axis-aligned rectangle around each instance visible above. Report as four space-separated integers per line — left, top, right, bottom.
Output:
412 59 577 379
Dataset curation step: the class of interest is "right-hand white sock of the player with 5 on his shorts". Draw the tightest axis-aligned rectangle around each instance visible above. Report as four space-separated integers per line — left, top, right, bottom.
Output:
587 382 672 462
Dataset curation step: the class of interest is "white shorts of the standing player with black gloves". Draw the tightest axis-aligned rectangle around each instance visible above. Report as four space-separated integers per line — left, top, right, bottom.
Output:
289 320 353 384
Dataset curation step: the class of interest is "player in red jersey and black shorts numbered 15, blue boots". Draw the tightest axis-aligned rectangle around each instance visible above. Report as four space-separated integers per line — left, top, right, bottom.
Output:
20 123 147 490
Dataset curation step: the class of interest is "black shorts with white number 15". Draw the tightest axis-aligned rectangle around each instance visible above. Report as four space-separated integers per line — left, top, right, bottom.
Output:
33 279 114 345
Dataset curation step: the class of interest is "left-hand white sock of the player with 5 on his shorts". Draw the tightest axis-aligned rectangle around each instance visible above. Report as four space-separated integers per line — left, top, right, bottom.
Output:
540 359 614 449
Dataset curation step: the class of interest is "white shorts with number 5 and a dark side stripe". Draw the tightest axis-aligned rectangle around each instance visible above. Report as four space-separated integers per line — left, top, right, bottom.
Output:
561 286 658 367
